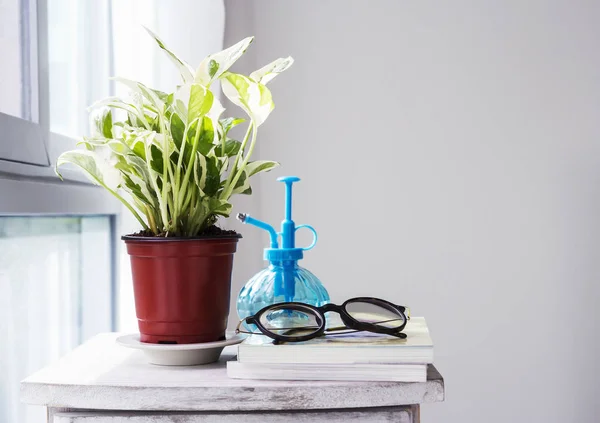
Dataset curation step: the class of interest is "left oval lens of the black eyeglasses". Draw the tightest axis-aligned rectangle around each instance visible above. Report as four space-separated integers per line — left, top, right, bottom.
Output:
260 306 323 336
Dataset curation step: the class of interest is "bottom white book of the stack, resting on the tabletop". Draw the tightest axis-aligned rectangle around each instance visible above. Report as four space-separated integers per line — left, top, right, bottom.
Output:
227 361 427 382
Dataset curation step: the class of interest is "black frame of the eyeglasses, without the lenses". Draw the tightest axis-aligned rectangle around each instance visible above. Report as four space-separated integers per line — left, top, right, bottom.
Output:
235 297 410 342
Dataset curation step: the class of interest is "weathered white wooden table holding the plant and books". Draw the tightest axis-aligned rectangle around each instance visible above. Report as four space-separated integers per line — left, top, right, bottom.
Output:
21 333 444 423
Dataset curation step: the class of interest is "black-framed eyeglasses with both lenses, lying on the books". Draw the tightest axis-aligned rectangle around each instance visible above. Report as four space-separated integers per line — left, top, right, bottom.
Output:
235 297 410 342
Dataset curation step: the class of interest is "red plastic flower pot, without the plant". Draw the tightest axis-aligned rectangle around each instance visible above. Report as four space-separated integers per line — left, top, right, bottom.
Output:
122 235 241 344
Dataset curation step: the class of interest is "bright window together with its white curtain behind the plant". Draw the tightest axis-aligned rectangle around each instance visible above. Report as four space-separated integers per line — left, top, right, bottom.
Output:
0 0 225 423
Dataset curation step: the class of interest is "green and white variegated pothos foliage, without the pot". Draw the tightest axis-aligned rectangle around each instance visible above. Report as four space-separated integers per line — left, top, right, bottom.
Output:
56 30 293 237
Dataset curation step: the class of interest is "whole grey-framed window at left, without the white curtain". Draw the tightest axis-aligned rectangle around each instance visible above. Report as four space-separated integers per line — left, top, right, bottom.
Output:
0 0 121 423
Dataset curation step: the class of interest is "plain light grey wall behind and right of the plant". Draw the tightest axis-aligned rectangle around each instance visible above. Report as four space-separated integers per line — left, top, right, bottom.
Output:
225 0 600 423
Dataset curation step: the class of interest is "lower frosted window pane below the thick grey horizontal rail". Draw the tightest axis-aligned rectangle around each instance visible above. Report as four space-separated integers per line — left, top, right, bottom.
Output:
0 215 115 422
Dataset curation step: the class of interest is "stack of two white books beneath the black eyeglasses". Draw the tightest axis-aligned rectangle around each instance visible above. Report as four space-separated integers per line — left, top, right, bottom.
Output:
227 317 433 382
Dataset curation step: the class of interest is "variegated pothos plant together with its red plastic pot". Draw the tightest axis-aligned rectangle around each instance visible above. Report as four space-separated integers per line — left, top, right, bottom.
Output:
56 27 293 343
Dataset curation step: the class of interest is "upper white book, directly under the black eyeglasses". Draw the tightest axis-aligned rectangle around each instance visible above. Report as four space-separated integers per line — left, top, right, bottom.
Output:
238 317 433 364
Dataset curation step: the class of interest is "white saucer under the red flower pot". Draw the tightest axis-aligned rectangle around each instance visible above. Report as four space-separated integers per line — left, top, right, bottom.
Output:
117 332 245 366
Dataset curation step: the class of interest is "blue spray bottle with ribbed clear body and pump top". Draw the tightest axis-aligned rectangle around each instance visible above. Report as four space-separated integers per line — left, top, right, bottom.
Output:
237 176 329 319
